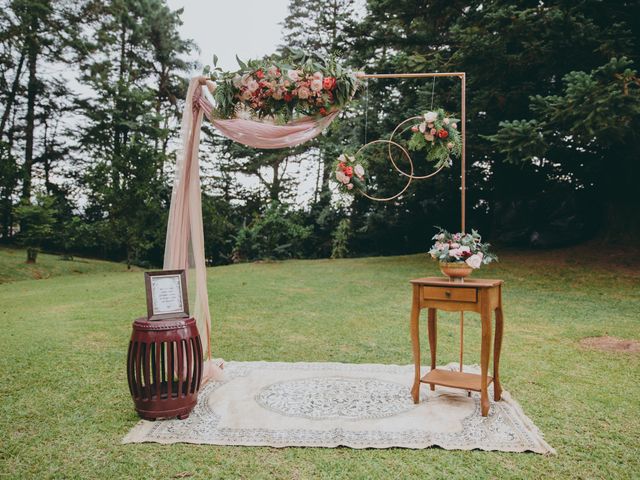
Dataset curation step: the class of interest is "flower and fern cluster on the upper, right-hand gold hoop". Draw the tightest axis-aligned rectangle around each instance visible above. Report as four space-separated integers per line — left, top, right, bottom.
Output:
408 108 462 168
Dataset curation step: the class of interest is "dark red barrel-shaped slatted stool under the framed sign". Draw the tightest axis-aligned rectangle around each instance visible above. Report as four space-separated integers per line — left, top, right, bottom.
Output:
127 318 202 420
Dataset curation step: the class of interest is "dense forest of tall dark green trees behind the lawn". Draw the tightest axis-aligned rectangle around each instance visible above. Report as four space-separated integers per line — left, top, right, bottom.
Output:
0 0 640 266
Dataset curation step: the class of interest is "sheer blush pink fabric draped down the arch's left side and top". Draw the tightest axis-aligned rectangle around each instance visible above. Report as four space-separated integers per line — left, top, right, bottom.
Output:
164 77 338 382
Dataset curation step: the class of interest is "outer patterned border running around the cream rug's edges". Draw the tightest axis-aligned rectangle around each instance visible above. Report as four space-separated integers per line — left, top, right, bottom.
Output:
122 361 556 455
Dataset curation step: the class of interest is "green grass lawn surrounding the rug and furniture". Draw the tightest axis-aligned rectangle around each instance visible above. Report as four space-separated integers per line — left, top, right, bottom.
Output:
0 249 640 479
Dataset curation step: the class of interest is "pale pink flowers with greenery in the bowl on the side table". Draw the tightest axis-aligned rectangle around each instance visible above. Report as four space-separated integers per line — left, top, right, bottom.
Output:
429 227 498 268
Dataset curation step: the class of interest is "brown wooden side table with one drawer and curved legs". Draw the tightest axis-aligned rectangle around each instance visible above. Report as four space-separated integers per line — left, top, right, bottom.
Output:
411 277 503 417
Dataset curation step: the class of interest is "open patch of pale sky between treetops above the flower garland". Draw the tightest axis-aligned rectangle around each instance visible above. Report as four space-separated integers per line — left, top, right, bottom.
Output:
168 0 289 70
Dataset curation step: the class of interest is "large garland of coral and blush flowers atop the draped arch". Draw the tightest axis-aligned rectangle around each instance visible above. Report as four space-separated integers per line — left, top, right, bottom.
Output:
204 50 356 123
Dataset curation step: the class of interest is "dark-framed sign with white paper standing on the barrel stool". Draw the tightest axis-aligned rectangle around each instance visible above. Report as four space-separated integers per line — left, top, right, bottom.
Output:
144 270 189 320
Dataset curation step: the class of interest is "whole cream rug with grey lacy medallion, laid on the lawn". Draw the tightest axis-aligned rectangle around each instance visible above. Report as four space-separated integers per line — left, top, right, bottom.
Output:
123 362 555 454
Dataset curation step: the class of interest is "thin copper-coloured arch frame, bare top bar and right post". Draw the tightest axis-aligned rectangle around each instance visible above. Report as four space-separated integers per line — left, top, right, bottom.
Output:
356 72 467 372
